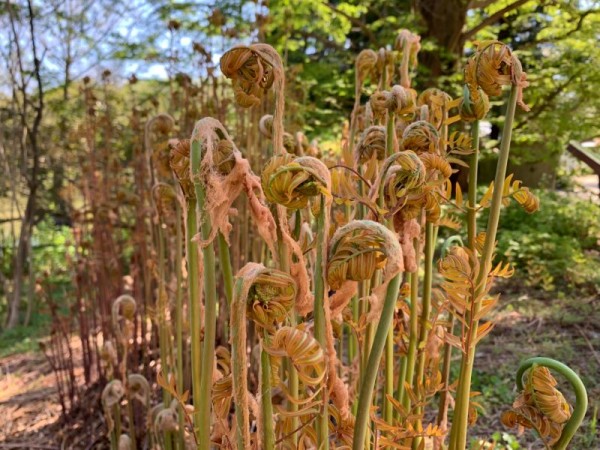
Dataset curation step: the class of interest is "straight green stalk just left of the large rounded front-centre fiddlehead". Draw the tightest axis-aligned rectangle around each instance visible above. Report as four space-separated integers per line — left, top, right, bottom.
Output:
313 195 329 450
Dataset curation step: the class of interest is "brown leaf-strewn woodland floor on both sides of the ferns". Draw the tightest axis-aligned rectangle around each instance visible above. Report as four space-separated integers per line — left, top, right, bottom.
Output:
0 285 600 450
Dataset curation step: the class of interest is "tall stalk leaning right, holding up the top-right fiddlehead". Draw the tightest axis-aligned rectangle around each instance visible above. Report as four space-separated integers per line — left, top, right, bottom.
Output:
449 85 517 450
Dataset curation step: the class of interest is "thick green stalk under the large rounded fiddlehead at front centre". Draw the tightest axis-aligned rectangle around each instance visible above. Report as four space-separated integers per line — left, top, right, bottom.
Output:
352 274 401 450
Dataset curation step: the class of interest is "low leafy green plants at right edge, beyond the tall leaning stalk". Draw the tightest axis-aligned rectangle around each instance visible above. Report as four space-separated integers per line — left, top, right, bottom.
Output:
490 190 600 291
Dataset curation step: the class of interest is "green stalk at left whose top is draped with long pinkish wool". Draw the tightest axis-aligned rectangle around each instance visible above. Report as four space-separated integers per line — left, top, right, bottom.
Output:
190 140 217 450
